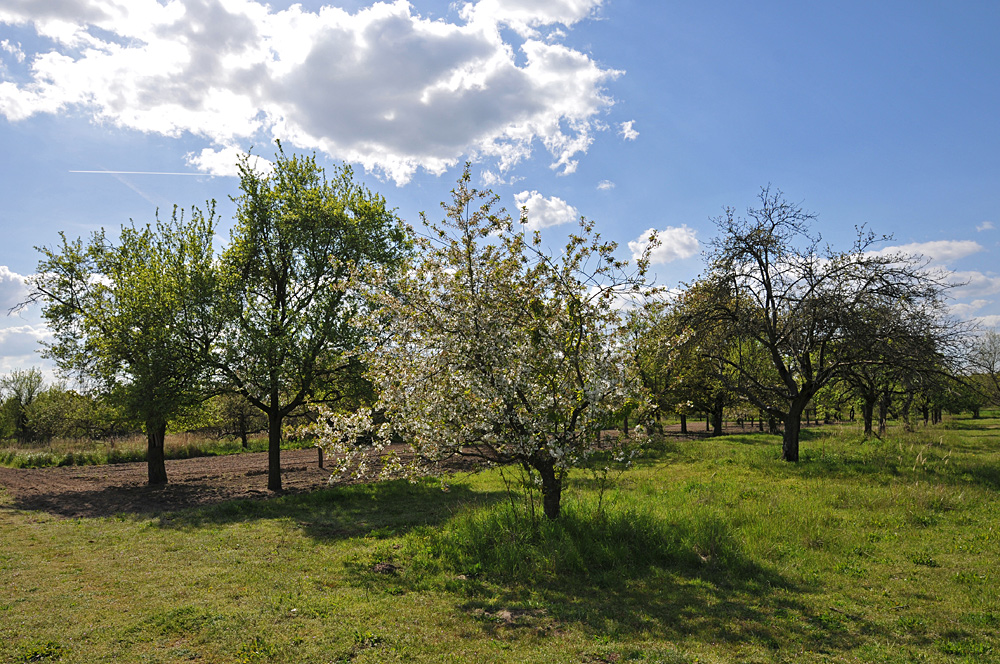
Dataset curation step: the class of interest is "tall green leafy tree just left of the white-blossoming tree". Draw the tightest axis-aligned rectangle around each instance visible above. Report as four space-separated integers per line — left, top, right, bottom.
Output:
216 146 408 491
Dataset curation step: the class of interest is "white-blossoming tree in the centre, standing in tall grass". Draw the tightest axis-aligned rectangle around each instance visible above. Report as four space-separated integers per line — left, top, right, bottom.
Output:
318 168 647 519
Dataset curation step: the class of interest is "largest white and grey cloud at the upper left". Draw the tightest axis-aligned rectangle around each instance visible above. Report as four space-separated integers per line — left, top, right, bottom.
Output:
0 0 631 184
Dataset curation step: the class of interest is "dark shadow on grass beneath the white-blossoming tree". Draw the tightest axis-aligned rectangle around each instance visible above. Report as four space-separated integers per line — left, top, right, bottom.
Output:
347 510 878 652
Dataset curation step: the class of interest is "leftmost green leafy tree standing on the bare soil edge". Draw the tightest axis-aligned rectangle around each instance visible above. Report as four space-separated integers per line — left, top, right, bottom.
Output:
25 208 216 484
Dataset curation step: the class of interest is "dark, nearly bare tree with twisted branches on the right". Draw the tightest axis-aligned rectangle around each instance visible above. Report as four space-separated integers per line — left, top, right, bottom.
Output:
692 187 950 461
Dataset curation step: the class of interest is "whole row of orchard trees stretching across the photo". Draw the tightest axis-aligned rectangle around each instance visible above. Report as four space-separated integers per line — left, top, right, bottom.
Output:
15 150 995 518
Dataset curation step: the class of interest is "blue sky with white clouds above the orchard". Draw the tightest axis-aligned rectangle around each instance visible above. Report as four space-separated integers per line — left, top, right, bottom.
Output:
0 0 1000 372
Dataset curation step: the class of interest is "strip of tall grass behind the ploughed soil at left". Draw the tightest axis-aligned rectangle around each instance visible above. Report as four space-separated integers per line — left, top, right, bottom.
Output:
0 433 312 468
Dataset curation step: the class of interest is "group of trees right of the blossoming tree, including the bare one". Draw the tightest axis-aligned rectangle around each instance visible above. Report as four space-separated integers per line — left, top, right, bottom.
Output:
631 188 1000 461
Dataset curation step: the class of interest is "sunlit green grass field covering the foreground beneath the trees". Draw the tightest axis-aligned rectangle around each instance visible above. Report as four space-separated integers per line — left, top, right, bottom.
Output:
0 418 1000 663
